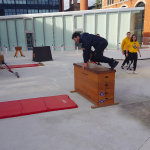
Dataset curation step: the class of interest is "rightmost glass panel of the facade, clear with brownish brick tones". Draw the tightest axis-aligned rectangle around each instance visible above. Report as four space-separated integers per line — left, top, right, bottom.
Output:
130 10 144 45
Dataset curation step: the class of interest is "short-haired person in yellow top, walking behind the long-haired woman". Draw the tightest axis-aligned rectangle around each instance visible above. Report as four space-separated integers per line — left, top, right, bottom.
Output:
121 32 131 69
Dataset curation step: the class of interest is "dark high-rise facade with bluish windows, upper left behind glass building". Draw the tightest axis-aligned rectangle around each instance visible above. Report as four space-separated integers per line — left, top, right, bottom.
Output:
0 0 64 16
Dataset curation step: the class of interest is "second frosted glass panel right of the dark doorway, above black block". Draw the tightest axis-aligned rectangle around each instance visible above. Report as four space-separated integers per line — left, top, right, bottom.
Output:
44 17 54 46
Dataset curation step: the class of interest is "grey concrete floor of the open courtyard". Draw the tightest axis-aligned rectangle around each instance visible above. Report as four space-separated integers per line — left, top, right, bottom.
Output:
0 51 150 150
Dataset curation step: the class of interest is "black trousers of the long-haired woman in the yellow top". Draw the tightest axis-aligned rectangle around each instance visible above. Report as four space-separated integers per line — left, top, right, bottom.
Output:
128 53 138 71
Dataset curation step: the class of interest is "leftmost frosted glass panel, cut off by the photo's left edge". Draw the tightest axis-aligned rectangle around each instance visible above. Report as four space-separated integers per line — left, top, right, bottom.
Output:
0 20 8 50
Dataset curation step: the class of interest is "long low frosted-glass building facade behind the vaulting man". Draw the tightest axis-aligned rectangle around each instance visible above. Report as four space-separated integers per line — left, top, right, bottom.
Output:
0 7 144 51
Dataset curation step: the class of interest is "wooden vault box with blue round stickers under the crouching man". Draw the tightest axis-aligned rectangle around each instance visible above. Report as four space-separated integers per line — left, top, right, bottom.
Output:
70 63 119 108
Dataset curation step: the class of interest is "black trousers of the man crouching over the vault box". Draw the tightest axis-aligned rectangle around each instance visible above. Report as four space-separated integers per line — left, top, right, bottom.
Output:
91 43 113 65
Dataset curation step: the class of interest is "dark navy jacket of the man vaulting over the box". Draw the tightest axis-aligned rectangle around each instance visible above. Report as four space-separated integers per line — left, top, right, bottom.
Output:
79 33 107 63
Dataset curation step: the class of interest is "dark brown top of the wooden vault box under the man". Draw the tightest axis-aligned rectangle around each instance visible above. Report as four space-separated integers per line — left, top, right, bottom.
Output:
73 63 116 74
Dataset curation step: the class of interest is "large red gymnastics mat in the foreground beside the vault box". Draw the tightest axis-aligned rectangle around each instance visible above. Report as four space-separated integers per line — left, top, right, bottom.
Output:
0 95 78 119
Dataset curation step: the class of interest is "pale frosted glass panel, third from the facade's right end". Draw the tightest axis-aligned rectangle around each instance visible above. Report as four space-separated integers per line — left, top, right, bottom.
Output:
107 13 118 49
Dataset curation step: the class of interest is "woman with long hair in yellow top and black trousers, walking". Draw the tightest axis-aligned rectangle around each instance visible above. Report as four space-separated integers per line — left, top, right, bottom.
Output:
126 34 141 74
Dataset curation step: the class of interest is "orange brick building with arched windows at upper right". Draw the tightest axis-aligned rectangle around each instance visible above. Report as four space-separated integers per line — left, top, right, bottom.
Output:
102 0 150 45
